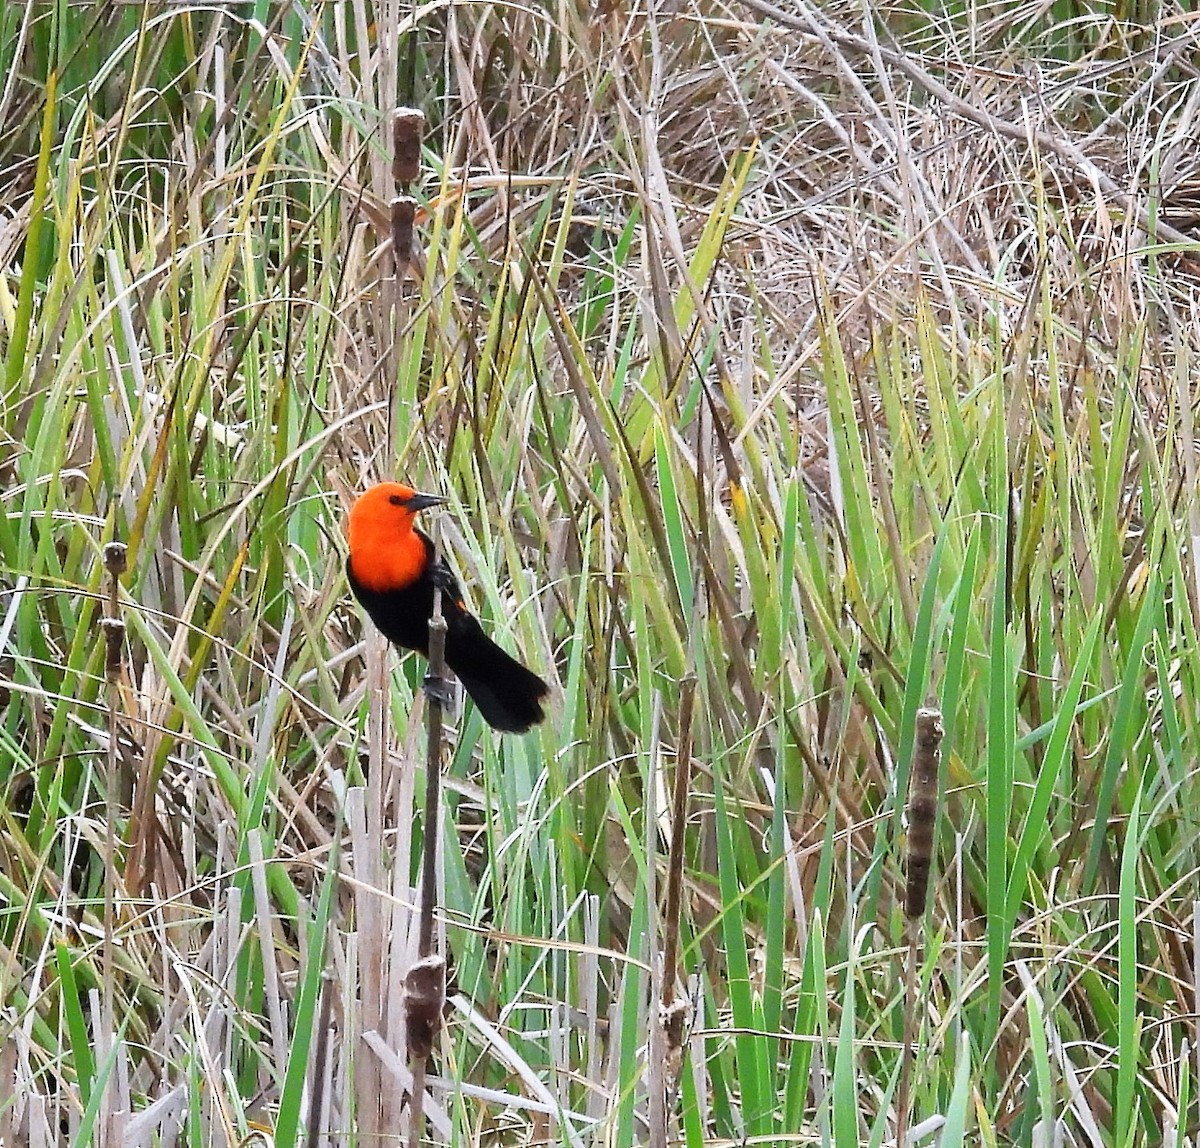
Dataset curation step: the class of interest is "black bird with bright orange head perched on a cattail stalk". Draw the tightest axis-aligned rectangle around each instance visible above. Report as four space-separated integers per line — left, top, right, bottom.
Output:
346 482 550 733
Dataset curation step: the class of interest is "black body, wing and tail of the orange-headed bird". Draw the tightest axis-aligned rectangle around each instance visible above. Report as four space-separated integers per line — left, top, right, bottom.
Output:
346 530 550 733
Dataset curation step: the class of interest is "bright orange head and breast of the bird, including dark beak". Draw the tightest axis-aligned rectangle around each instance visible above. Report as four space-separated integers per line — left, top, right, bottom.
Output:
349 482 445 594
